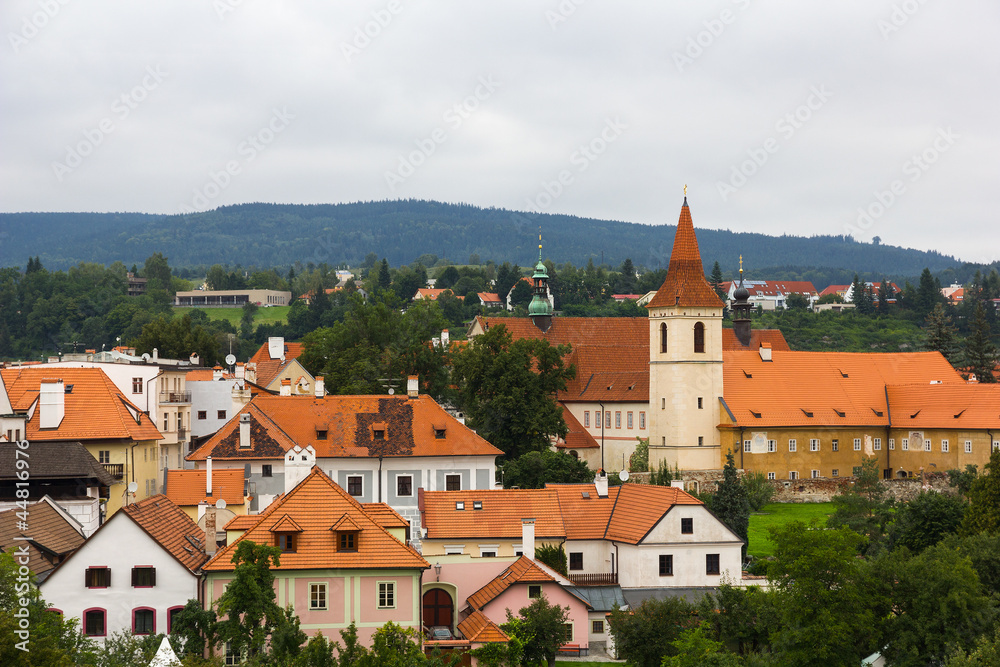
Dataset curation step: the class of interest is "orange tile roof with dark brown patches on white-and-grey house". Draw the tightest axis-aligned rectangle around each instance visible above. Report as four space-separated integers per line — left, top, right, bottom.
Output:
188 394 502 461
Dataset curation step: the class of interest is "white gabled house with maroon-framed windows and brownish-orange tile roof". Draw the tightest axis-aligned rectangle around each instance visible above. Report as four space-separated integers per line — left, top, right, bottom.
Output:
40 495 214 641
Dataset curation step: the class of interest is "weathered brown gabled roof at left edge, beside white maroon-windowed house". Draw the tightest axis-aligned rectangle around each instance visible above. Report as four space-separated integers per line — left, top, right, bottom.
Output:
0 496 85 580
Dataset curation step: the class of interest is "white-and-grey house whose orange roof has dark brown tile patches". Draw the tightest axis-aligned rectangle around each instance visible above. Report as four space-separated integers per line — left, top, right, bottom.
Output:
188 377 502 539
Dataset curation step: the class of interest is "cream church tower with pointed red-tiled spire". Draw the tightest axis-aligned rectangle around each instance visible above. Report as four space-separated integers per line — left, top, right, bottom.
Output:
646 196 724 470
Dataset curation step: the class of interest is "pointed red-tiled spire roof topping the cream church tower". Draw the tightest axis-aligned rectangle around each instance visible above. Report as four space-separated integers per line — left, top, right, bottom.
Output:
646 197 724 309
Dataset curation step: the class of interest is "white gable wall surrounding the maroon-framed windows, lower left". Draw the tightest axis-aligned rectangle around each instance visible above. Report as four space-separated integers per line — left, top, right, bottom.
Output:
40 514 198 641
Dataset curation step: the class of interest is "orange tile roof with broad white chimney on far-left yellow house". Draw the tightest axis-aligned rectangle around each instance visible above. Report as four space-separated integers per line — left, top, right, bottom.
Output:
0 366 163 441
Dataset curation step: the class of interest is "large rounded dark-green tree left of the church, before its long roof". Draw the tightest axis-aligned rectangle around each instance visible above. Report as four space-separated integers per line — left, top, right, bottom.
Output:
453 325 576 458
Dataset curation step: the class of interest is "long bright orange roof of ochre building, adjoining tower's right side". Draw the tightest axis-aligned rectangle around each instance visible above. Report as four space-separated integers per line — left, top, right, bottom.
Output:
722 350 964 427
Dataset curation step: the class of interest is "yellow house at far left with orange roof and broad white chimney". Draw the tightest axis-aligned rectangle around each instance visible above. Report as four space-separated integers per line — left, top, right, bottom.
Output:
0 365 163 517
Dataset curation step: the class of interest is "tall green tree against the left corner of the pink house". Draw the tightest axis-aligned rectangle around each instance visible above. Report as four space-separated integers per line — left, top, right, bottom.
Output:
216 540 284 657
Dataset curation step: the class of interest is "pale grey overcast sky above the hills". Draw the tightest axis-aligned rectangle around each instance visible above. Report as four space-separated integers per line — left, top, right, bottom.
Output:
0 0 1000 263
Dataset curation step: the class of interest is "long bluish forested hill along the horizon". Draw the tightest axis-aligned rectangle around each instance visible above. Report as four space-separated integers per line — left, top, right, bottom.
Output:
0 200 958 276
